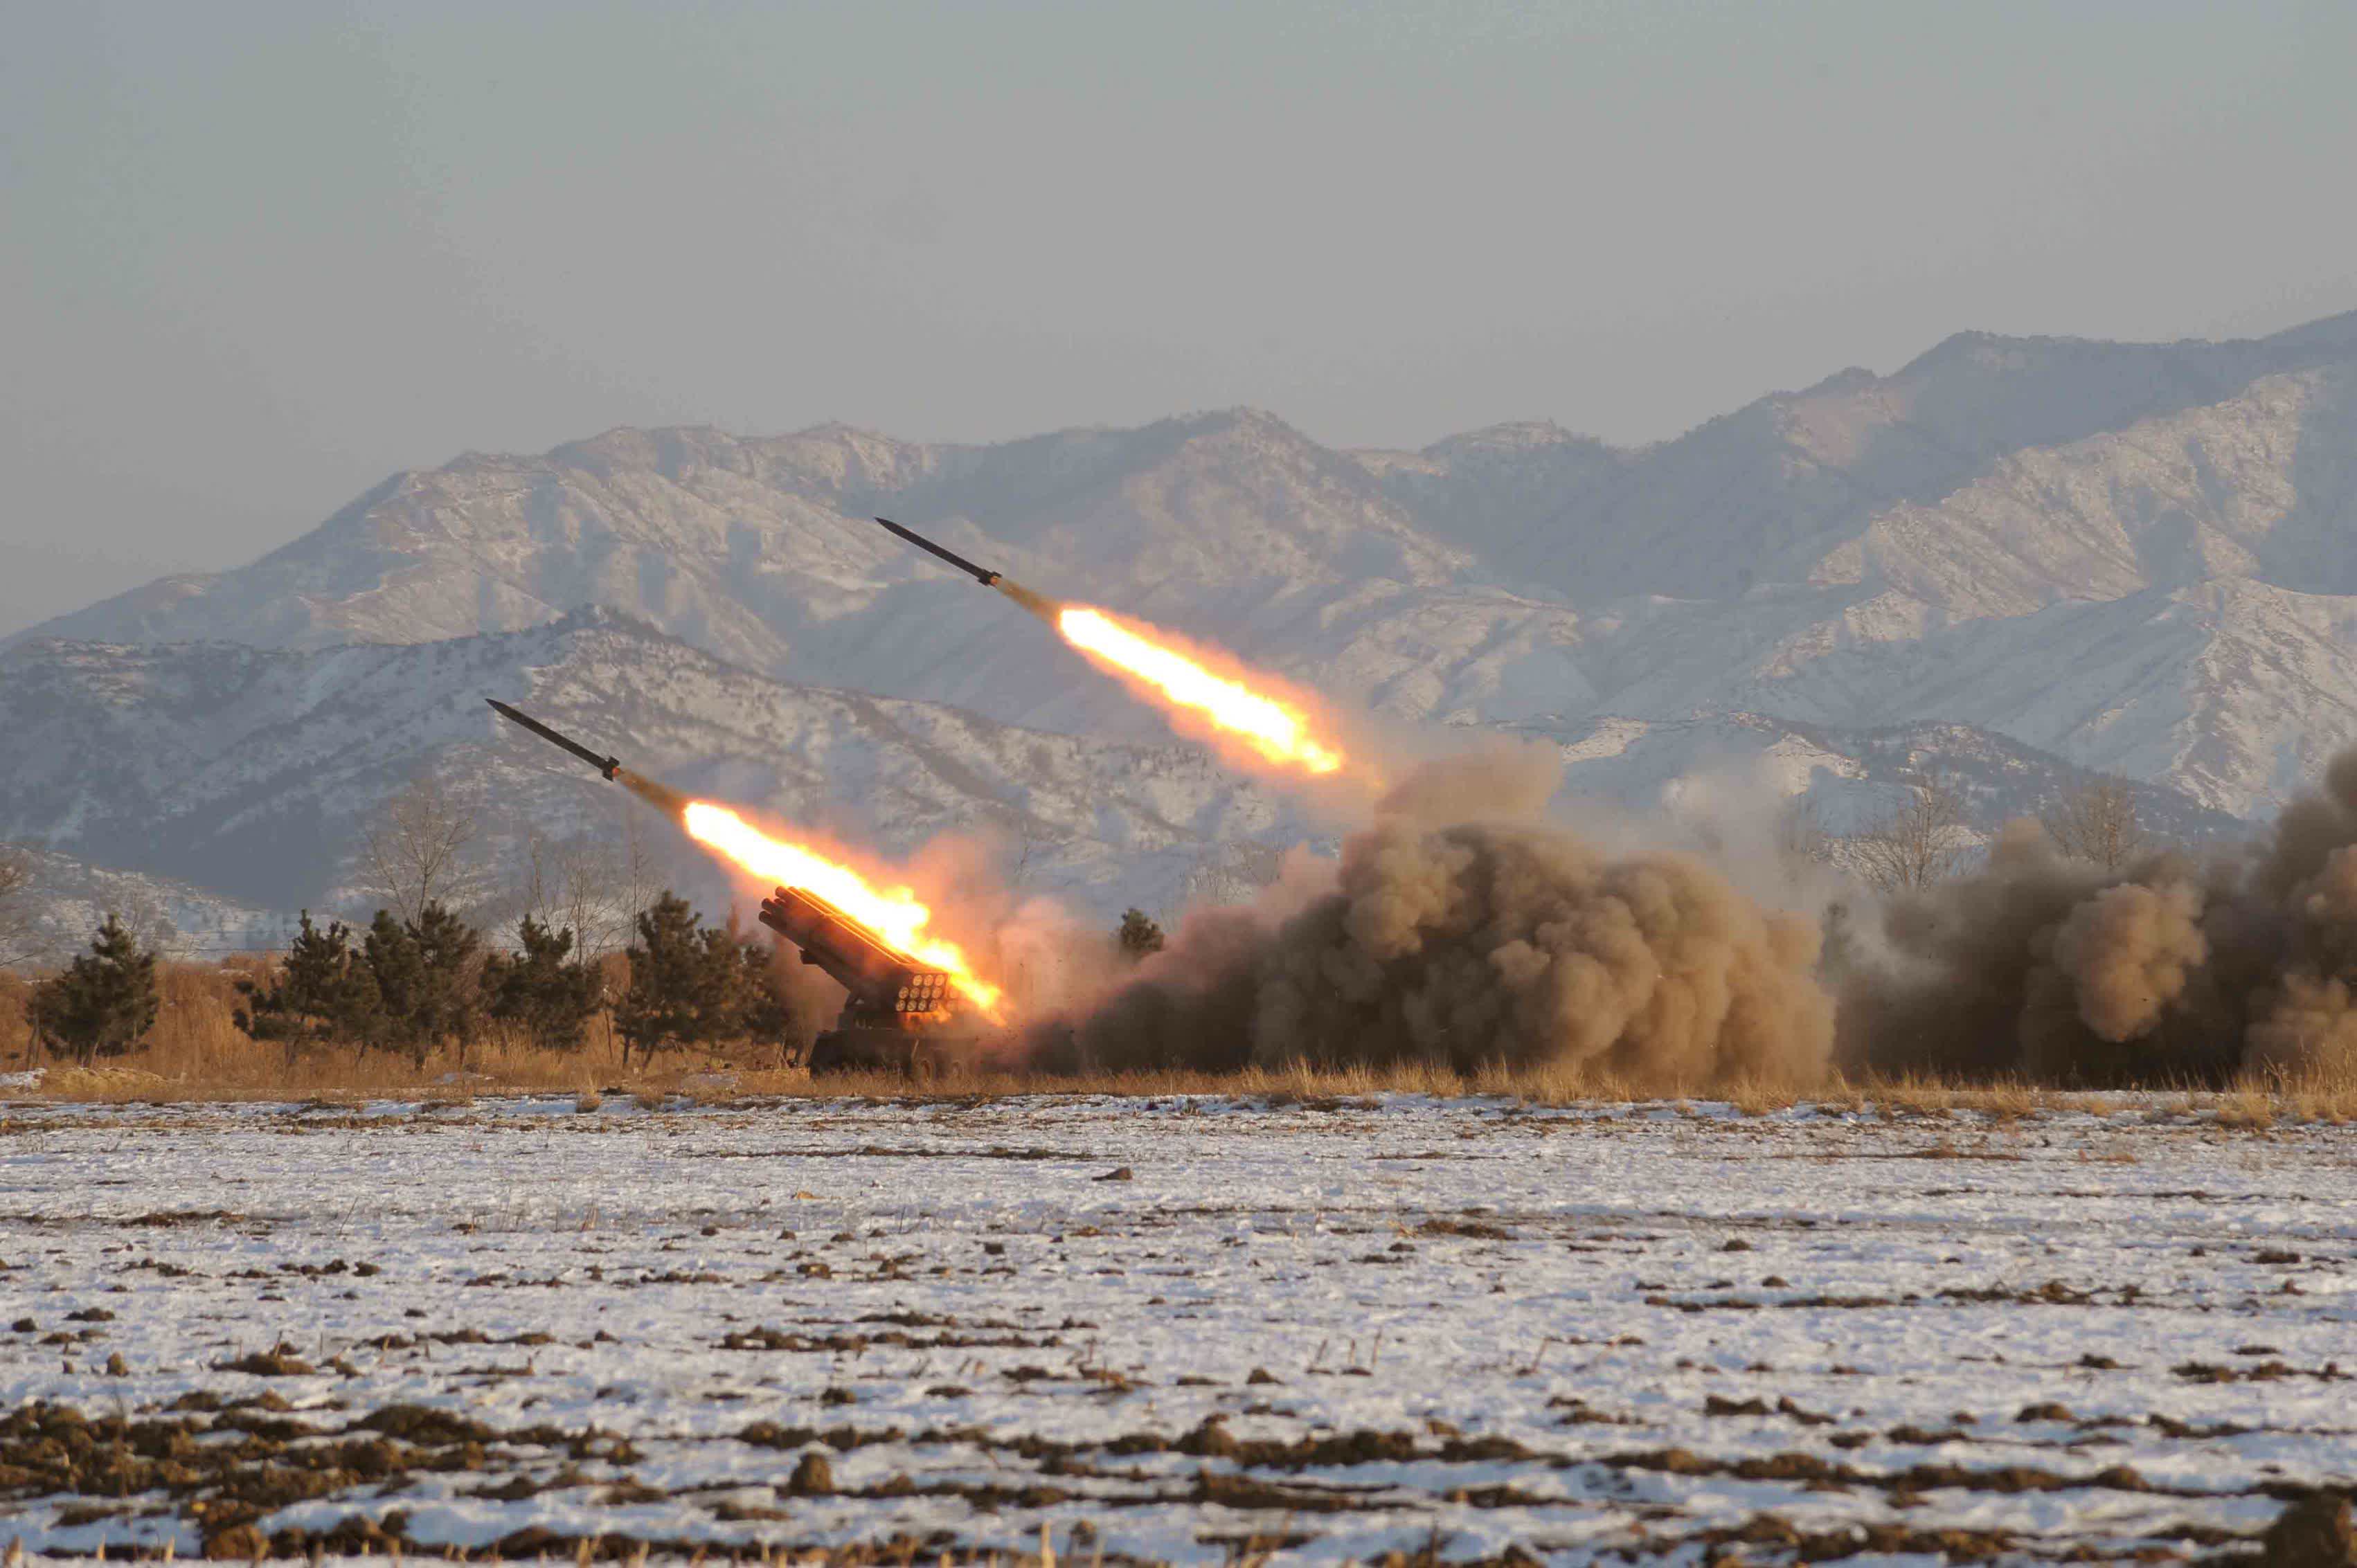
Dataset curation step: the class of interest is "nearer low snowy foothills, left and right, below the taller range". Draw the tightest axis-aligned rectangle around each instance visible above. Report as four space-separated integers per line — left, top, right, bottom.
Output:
0 609 2241 928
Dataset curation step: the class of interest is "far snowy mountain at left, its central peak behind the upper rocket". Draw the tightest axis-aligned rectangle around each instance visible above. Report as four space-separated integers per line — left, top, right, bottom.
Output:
4 413 1575 740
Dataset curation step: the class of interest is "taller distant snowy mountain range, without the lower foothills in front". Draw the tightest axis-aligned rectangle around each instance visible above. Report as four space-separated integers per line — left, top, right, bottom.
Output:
17 314 2357 813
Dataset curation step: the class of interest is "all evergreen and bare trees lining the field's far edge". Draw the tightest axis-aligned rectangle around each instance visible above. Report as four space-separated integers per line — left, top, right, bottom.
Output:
0 778 2159 1066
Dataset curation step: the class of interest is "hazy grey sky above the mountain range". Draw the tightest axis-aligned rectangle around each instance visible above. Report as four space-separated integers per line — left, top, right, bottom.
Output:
0 0 2357 632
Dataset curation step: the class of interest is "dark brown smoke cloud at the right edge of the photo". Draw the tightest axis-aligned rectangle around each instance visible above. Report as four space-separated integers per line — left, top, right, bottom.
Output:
1841 753 2357 1085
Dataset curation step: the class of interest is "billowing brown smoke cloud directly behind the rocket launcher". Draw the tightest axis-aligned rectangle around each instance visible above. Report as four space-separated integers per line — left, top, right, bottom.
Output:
1042 748 1834 1090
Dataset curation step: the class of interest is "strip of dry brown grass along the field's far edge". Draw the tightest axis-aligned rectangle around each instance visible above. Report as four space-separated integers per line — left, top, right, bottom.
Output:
0 959 2357 1112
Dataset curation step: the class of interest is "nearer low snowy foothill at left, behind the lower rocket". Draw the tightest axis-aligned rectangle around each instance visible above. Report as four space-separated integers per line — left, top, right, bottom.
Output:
0 611 1315 910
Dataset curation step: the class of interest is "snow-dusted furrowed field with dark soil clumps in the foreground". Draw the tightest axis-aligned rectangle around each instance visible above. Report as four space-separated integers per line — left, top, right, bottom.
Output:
0 1099 2357 1561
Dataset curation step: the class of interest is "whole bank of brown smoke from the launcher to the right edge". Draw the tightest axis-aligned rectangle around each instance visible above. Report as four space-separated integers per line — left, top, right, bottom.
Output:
1034 748 2357 1087
